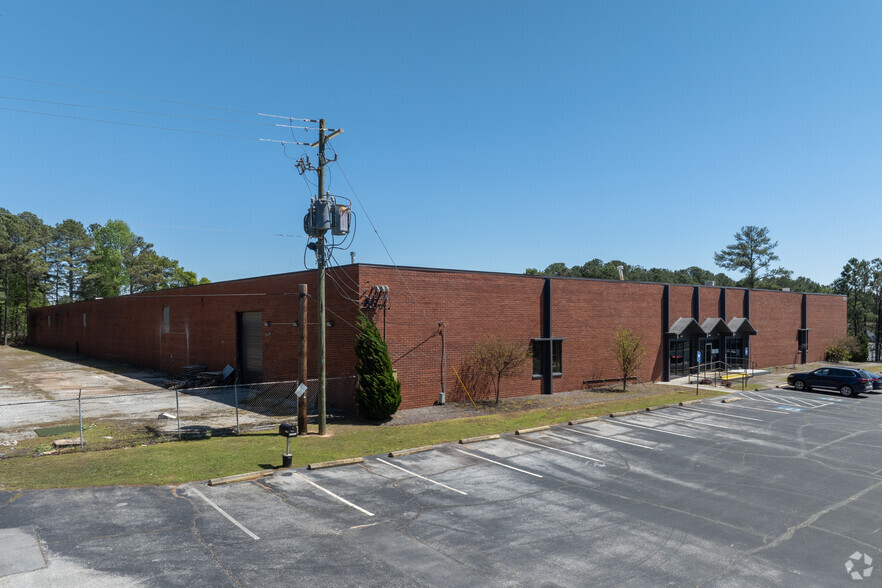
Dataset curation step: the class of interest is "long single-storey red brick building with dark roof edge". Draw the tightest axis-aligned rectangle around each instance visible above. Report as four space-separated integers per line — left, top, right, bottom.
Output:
28 264 846 408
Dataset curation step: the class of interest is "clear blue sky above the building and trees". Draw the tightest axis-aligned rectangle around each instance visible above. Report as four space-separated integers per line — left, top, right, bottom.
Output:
0 0 882 283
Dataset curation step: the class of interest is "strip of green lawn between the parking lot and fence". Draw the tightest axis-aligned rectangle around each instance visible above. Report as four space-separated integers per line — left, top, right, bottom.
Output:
0 389 722 490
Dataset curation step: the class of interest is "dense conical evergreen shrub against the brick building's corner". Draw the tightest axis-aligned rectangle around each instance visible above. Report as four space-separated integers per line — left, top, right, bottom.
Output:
355 314 401 421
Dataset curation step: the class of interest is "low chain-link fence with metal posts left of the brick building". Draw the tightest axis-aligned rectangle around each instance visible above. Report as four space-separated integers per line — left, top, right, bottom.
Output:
0 376 357 458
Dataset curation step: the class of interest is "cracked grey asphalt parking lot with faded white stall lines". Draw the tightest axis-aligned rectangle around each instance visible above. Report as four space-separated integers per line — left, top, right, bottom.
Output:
0 389 882 586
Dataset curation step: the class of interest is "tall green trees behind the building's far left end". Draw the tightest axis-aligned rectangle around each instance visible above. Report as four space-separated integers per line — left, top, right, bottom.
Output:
0 208 209 339
